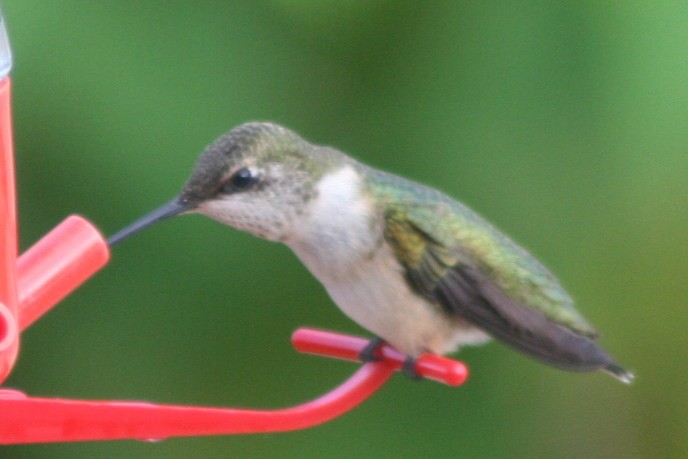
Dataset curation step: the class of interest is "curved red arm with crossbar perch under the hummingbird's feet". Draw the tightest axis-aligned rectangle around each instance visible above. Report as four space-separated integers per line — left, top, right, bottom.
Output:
0 328 468 444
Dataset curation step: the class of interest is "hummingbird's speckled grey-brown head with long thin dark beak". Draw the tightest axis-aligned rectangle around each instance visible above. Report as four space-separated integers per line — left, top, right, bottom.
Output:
108 122 345 245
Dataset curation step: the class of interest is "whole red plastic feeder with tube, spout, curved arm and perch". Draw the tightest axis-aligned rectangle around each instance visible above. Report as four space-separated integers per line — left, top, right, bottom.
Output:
0 11 468 444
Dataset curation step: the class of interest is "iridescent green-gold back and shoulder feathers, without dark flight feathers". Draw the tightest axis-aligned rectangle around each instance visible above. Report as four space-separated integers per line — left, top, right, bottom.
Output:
377 173 598 338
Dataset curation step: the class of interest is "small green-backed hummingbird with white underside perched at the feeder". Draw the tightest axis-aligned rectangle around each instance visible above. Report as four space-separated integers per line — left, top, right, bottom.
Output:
108 122 634 383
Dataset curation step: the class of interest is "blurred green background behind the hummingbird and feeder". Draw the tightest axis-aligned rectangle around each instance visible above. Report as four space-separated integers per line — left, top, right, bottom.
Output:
0 0 688 459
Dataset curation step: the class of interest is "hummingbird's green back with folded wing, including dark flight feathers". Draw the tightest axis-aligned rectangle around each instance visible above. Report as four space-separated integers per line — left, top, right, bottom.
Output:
371 171 636 373
